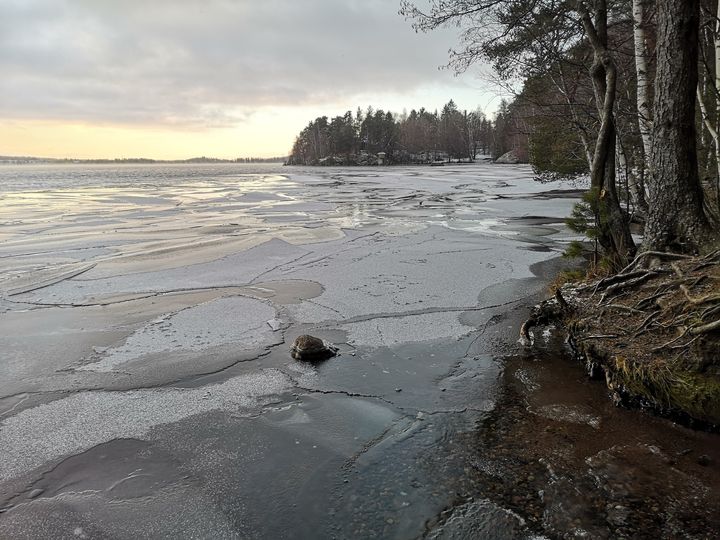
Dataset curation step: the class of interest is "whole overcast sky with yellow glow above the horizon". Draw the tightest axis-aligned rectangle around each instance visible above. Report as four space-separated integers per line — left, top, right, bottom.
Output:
0 0 498 159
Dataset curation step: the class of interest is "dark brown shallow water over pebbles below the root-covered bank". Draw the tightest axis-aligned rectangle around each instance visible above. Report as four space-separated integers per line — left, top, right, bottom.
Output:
416 257 720 540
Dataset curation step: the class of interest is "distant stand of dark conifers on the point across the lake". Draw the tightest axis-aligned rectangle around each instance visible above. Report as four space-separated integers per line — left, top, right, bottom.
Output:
288 100 526 165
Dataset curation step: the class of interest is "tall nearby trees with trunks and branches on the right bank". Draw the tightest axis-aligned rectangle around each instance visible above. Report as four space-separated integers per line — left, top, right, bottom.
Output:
400 0 720 269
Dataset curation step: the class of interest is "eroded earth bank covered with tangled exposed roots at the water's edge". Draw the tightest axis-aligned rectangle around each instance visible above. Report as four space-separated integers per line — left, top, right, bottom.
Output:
521 255 720 426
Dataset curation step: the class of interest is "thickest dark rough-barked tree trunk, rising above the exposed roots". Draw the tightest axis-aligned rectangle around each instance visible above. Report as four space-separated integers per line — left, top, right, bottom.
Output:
643 0 718 253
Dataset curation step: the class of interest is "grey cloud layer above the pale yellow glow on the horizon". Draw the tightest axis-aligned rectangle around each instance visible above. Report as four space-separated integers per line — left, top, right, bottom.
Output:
0 0 464 127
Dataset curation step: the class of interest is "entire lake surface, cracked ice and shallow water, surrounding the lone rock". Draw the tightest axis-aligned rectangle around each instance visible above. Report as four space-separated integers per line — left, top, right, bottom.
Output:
0 164 720 538
